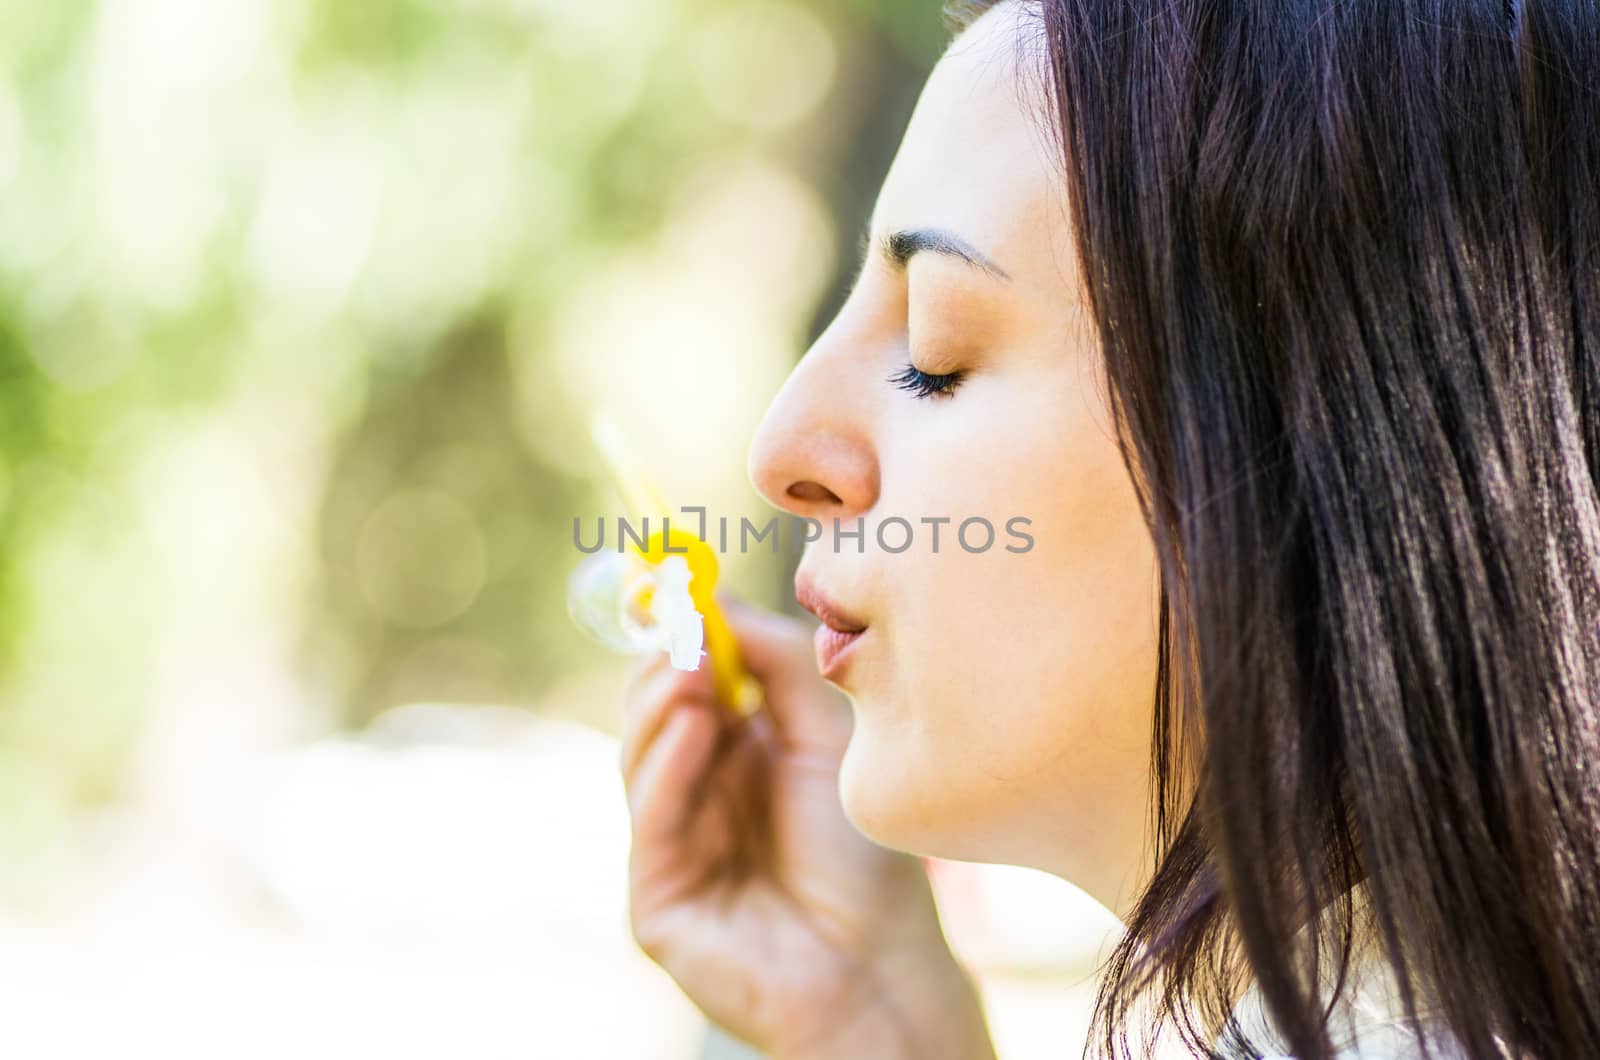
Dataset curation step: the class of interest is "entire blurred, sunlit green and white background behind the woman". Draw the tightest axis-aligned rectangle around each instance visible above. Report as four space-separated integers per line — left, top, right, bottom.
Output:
0 0 1107 1060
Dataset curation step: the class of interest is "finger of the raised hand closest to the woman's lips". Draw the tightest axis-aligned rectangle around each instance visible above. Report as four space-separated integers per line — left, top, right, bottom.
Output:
717 591 851 753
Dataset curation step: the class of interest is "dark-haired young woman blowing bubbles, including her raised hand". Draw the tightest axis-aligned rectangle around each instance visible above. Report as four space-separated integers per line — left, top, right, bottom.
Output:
622 0 1600 1060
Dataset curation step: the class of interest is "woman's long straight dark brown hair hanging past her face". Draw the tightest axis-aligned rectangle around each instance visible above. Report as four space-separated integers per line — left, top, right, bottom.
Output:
947 0 1600 1060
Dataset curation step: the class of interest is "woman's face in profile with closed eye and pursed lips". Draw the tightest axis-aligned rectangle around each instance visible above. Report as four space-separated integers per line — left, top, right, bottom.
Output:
750 5 1158 909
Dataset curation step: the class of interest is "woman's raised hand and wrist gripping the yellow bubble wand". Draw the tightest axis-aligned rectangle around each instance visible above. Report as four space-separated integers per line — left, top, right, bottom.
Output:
621 596 994 1060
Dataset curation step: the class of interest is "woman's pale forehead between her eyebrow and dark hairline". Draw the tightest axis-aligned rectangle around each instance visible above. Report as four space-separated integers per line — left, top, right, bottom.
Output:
874 3 1070 283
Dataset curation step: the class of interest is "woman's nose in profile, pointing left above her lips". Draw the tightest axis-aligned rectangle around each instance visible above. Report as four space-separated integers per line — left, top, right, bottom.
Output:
749 320 878 522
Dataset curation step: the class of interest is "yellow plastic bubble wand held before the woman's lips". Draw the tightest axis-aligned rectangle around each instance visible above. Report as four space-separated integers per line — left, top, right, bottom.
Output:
589 413 762 717
